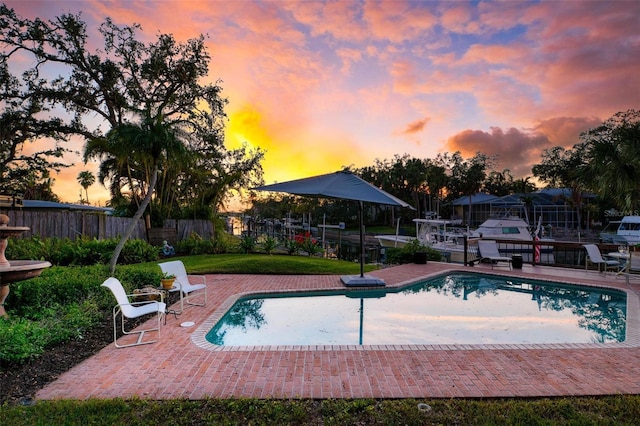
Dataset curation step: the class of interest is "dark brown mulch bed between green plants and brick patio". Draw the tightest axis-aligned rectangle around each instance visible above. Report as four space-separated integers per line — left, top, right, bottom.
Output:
0 293 178 406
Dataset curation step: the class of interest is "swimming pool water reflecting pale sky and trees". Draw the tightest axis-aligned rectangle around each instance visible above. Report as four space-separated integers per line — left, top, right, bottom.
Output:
206 273 626 346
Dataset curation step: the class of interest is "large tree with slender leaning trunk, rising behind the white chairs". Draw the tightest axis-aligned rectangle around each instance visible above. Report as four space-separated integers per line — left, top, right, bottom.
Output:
0 5 261 272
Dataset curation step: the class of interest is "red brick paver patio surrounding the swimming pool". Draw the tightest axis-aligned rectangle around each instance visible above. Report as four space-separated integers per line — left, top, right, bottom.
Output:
36 262 640 399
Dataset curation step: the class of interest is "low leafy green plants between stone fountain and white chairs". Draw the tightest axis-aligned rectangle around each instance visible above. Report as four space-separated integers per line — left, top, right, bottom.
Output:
0 265 162 364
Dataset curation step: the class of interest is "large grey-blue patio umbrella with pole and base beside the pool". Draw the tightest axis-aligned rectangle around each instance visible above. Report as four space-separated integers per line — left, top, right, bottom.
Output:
253 170 411 286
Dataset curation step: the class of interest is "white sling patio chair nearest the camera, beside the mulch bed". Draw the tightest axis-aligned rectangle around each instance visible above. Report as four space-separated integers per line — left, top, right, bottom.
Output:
102 277 167 348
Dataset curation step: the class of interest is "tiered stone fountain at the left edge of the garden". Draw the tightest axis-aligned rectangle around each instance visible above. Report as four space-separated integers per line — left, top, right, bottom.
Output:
0 214 51 318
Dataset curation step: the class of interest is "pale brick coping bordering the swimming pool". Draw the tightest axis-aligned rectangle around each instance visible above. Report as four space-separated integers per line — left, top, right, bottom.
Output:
191 264 640 351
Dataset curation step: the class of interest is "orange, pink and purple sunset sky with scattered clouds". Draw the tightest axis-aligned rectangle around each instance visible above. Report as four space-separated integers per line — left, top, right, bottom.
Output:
6 0 640 205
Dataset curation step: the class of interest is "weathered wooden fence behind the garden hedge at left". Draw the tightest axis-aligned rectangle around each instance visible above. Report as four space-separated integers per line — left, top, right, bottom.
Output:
5 210 213 245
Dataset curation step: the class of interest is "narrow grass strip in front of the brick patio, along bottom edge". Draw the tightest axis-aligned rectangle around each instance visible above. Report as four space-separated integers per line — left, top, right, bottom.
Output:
0 395 640 426
